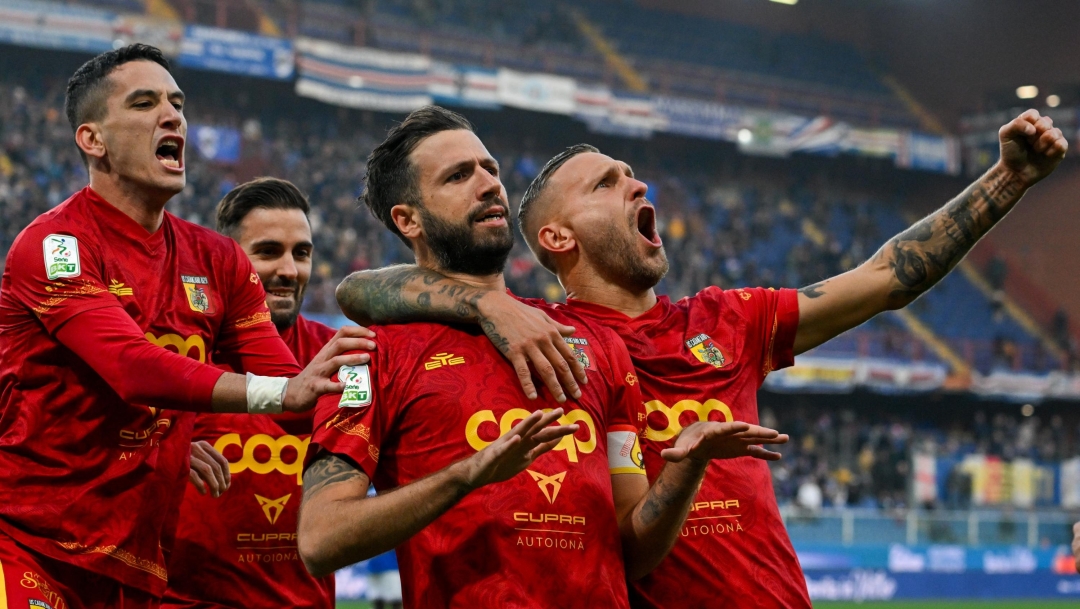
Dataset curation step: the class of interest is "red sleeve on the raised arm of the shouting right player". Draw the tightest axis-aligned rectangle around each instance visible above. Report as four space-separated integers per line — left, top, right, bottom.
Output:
699 287 799 384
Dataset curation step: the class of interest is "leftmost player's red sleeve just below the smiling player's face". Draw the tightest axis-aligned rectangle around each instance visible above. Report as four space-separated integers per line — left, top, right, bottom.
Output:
216 242 301 377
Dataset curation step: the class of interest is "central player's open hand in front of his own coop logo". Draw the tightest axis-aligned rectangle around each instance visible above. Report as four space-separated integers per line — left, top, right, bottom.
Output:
461 408 578 489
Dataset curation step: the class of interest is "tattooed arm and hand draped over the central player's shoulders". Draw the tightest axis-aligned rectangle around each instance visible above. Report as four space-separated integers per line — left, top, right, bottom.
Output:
337 265 588 402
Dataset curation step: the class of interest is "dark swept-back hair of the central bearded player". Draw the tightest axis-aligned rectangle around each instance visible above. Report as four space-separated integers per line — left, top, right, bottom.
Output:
360 106 473 247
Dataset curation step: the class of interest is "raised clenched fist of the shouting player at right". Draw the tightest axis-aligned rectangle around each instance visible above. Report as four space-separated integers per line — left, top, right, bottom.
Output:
998 110 1069 187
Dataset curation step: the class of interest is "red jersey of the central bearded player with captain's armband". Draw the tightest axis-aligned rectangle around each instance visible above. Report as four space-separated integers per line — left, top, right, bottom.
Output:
309 304 644 609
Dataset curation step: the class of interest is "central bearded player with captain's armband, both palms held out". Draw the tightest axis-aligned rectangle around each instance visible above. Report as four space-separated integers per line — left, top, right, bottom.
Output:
299 107 786 609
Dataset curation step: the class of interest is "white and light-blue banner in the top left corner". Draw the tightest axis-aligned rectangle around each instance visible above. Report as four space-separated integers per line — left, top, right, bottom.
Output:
0 0 117 53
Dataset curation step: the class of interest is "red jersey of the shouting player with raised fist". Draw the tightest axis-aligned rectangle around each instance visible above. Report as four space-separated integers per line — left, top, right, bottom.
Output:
567 287 810 609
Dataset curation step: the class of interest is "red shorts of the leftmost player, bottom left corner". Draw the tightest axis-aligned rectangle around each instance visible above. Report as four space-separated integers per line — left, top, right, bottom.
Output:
0 533 158 609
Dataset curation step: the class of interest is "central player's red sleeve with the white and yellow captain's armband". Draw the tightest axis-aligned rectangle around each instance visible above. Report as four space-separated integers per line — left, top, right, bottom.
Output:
600 328 646 476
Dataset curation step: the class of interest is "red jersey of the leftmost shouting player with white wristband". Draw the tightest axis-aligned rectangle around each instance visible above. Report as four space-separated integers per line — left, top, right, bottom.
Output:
0 187 299 596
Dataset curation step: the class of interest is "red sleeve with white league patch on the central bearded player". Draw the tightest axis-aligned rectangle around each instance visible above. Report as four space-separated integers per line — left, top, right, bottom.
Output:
308 350 392 478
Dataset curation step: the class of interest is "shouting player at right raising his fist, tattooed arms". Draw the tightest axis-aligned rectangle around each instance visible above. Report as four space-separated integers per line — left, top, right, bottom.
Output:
338 110 1067 608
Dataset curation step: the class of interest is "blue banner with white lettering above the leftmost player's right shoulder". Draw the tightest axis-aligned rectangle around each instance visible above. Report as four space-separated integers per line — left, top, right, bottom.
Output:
178 26 294 80
